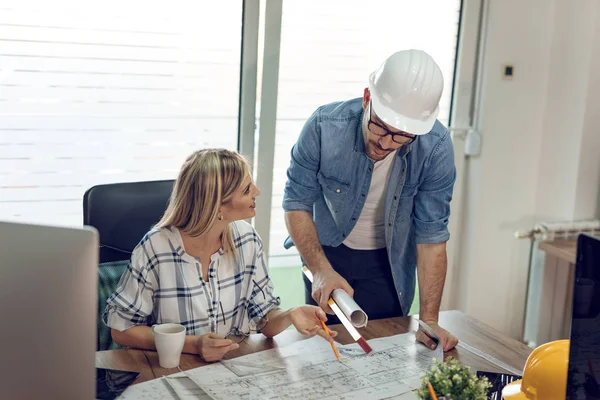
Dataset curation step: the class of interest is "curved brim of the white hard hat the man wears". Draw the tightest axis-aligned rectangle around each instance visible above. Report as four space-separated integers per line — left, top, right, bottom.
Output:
369 73 440 135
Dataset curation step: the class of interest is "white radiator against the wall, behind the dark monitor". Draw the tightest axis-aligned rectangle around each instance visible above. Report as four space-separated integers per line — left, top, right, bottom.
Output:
515 220 600 348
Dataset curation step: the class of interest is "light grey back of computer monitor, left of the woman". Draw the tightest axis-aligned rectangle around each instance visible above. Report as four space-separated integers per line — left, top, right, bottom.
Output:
0 222 98 399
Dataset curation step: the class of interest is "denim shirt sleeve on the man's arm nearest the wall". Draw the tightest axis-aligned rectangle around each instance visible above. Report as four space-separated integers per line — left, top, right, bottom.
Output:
413 133 456 244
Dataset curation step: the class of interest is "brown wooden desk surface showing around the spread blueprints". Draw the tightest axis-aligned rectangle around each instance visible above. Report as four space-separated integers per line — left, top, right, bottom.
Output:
96 311 531 383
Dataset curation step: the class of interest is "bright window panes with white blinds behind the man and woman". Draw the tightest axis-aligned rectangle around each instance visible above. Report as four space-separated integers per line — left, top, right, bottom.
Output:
0 0 468 266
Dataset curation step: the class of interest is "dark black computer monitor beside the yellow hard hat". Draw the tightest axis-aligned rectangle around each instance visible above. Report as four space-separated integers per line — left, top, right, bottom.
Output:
566 234 600 400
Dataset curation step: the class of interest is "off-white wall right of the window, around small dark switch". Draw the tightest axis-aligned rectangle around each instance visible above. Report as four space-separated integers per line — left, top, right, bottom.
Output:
456 0 600 338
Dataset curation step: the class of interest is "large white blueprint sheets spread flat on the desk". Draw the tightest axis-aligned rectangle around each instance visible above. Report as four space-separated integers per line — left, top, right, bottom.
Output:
120 333 443 400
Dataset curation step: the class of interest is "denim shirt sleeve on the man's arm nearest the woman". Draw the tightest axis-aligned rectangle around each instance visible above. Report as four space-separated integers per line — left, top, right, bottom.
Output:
282 108 321 214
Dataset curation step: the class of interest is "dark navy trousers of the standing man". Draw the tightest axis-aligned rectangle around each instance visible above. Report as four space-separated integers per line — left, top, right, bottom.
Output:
303 244 404 324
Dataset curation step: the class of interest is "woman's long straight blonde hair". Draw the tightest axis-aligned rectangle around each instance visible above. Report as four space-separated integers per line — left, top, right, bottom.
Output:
156 149 250 254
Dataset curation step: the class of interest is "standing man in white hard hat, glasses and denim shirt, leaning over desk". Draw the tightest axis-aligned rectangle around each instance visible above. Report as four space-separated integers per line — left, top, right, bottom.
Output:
283 50 458 351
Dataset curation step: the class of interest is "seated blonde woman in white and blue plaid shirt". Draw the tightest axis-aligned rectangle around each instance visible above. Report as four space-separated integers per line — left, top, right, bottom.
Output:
103 149 336 361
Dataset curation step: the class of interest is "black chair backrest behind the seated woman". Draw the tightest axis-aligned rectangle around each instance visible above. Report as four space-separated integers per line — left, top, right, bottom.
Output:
83 180 175 263
